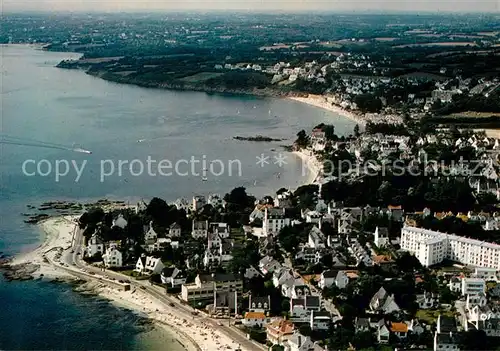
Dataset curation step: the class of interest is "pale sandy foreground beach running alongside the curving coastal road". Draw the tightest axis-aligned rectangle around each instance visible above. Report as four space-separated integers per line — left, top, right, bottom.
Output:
11 216 254 351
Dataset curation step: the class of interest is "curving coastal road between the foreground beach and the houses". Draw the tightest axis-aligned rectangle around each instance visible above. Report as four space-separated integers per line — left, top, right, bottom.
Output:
61 226 266 351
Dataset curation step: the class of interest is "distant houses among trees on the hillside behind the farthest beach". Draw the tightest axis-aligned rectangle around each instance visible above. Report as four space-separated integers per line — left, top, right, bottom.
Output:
214 49 500 124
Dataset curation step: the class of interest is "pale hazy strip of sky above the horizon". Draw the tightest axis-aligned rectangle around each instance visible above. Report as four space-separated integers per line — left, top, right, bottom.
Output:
0 0 500 13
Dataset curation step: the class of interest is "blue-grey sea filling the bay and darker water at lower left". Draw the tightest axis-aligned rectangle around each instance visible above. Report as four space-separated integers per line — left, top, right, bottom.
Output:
0 45 355 351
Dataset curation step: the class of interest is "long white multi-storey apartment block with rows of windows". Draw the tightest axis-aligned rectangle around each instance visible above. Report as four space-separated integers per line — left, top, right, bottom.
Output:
401 226 500 269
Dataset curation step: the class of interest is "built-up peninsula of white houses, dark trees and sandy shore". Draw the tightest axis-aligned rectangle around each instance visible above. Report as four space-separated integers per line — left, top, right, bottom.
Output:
2 121 500 350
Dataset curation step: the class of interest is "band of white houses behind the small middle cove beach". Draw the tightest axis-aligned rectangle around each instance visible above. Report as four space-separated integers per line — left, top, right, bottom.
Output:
300 128 500 199
